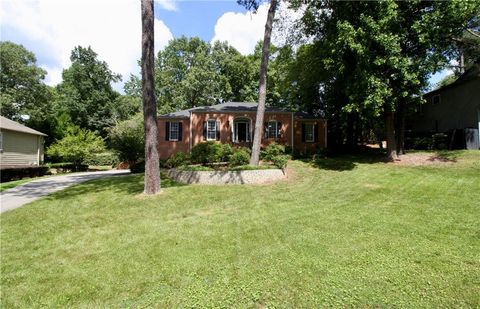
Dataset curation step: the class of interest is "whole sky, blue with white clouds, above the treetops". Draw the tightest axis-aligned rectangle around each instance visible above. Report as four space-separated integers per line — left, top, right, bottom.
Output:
0 0 446 92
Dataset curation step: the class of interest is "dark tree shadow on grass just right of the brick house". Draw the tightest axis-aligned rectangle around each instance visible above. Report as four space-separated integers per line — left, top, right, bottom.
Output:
302 151 389 171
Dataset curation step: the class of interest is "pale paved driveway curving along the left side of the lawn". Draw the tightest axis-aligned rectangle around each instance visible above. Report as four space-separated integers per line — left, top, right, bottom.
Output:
0 170 130 213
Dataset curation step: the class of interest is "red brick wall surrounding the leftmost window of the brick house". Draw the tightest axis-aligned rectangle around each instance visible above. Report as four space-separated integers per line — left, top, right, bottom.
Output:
157 118 190 160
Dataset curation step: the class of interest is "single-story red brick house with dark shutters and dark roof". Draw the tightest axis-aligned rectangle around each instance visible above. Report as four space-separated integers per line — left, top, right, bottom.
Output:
158 102 327 159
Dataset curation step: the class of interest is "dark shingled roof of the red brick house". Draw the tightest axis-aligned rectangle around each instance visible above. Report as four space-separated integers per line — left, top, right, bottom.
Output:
159 102 319 119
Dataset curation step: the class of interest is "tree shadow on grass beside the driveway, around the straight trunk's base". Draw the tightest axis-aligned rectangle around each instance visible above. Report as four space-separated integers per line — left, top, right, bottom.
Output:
46 173 184 200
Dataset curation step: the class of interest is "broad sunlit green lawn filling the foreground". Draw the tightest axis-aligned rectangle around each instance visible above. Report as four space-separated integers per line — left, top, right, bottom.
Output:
1 151 480 308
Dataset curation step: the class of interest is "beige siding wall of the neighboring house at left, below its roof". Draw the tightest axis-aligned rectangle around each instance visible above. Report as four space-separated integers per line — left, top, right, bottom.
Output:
0 130 43 165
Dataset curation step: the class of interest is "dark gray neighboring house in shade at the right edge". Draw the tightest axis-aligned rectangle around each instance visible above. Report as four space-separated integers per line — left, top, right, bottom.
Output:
406 63 480 149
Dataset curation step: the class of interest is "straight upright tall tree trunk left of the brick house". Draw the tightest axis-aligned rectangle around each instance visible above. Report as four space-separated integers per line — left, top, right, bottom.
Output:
142 0 160 194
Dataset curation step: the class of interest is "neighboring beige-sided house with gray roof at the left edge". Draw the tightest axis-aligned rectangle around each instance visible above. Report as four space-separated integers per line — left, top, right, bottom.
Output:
0 116 47 167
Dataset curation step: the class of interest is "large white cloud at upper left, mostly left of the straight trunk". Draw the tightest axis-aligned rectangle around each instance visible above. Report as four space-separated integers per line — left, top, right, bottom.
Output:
0 0 173 91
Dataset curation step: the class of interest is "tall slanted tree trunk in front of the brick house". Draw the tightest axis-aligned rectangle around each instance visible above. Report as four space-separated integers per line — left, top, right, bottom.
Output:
250 0 276 165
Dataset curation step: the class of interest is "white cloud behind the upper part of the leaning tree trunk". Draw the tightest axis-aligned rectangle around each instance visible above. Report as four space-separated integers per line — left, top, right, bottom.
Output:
212 2 302 55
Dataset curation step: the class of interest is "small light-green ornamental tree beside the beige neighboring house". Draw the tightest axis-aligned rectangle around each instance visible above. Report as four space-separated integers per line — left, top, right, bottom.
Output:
47 126 105 167
